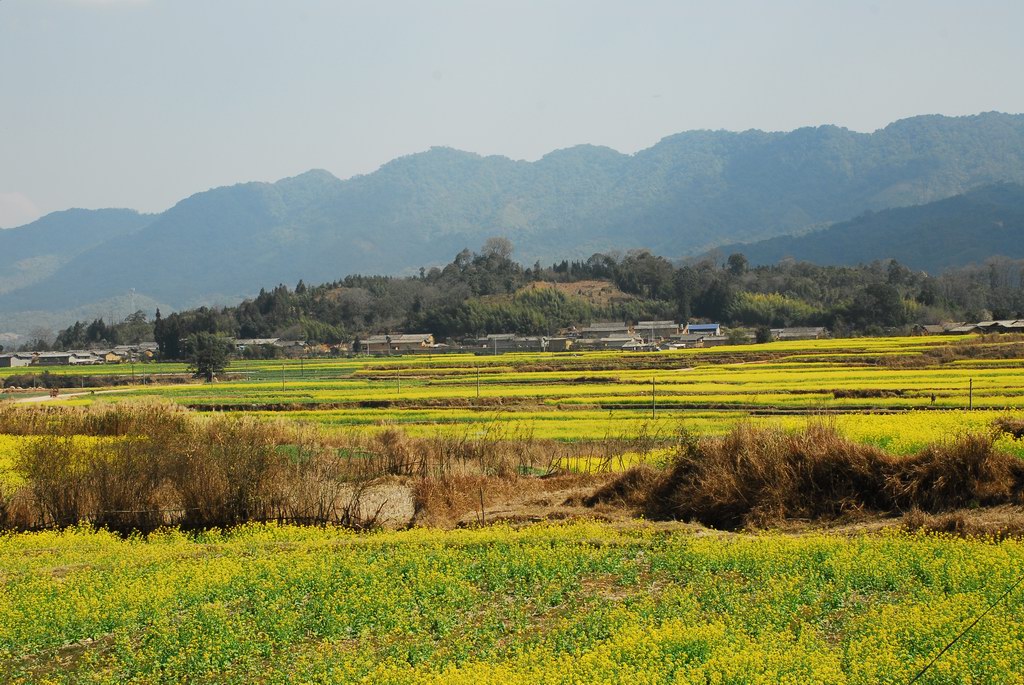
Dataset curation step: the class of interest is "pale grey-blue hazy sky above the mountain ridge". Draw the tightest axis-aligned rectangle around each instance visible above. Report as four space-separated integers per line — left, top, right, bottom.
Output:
0 0 1024 227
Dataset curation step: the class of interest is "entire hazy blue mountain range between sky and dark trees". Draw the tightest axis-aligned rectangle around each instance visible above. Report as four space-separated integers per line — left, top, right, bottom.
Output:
0 113 1024 333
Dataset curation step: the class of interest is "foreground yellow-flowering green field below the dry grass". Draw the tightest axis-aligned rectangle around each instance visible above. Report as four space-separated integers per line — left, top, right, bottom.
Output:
0 523 1024 685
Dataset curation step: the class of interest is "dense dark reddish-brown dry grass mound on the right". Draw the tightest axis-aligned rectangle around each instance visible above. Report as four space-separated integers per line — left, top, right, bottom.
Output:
593 424 1024 528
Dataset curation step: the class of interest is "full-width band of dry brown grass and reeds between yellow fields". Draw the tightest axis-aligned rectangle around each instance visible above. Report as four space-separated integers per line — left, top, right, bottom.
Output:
8 403 1024 530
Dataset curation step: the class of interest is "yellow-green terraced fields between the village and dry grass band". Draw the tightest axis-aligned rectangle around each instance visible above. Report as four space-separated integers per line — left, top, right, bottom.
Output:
4 337 1024 453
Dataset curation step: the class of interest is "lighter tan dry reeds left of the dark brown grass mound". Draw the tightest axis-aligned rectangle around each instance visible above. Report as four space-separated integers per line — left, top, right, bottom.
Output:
0 402 649 530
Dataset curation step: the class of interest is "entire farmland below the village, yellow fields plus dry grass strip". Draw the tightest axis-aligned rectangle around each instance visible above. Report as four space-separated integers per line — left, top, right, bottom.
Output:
0 337 1024 685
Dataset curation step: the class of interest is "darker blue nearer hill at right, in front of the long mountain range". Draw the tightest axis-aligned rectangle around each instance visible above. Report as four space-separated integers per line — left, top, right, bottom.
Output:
722 183 1024 273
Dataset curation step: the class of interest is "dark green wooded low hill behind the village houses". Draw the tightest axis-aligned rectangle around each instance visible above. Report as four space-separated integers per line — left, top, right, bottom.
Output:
41 239 1024 358
